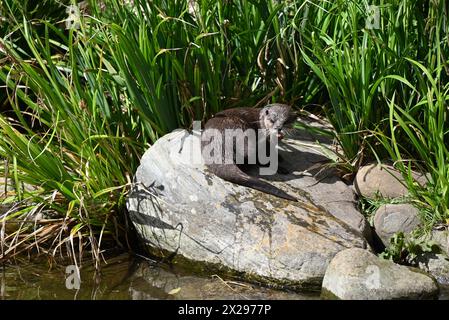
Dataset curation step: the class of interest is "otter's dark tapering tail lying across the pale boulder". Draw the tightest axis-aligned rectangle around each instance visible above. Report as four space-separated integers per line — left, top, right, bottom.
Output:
208 164 298 201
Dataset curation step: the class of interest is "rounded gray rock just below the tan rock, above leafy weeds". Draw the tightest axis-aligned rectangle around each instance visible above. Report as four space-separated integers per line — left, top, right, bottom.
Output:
374 203 421 247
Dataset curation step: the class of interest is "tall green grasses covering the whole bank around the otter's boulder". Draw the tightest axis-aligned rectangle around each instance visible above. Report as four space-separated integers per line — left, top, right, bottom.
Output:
0 0 449 259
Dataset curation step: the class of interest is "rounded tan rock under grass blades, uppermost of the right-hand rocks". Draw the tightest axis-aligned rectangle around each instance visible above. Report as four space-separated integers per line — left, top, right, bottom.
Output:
354 164 426 198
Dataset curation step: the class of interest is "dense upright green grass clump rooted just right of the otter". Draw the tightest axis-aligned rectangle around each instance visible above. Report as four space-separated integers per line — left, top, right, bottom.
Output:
301 0 448 171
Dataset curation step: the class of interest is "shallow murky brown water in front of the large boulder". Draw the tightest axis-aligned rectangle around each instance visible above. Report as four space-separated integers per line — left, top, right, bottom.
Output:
0 254 319 300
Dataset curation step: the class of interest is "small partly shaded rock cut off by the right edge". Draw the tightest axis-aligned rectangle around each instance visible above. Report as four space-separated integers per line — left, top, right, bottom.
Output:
415 252 449 284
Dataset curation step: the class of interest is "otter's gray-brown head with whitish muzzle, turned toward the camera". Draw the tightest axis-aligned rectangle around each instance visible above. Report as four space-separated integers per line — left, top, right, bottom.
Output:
259 103 295 140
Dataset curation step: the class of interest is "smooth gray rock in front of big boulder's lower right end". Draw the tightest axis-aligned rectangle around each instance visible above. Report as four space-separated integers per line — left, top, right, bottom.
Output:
322 248 439 300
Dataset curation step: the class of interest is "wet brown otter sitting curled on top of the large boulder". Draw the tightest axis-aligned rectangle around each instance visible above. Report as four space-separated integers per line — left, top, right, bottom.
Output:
201 103 297 201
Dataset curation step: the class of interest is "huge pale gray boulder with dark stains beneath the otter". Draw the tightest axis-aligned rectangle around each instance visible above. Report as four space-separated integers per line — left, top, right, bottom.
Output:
127 130 367 289
